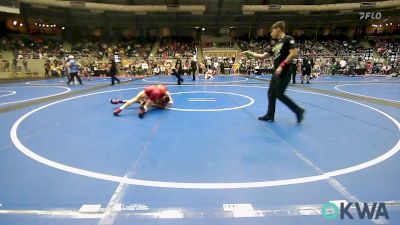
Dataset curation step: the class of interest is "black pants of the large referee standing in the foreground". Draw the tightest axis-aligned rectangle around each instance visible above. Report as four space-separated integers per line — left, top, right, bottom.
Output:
267 68 302 117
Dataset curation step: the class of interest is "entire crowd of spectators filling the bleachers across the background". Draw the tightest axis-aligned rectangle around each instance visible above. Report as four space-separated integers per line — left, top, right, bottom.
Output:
0 36 400 75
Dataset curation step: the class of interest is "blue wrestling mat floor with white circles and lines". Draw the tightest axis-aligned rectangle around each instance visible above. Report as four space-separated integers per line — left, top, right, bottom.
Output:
0 75 400 225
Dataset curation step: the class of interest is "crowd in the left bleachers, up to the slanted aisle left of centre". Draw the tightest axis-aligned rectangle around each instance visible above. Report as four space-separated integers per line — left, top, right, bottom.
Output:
0 36 154 76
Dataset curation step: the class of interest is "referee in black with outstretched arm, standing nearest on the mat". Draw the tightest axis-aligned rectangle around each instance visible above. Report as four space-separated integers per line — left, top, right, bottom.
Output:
241 21 305 123
